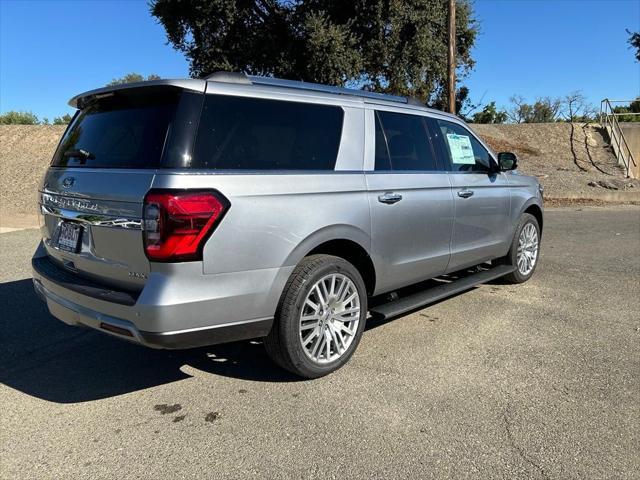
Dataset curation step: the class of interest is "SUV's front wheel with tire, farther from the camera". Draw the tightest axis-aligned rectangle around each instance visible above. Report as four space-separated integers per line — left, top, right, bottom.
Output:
503 213 540 283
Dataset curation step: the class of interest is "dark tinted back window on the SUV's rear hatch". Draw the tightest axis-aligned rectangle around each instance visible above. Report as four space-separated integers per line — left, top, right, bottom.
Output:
52 90 180 168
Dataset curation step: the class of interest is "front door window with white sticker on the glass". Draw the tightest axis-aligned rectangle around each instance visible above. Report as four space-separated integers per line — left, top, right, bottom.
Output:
436 120 491 172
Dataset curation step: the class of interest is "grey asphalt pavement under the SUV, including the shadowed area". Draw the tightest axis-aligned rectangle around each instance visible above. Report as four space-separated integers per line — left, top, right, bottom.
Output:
0 207 640 479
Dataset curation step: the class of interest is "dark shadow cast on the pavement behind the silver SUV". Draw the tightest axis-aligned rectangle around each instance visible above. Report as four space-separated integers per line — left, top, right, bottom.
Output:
0 279 299 403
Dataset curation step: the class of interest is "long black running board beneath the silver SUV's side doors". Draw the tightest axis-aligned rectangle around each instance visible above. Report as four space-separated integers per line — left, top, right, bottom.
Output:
369 265 515 319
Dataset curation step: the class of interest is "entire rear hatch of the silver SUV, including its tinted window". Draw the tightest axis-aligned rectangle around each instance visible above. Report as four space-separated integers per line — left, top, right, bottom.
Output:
39 83 203 291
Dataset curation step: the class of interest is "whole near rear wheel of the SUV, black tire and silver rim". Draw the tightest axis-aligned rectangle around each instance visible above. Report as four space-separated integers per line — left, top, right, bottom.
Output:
264 255 367 378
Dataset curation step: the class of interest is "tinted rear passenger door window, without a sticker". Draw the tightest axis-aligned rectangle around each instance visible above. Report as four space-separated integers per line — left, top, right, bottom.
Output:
376 111 438 171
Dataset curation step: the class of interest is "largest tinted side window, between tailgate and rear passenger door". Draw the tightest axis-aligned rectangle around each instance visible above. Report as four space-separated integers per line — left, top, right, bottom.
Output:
191 95 344 170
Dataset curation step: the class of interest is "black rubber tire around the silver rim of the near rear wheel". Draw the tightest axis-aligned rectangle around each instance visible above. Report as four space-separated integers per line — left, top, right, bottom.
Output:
264 255 367 378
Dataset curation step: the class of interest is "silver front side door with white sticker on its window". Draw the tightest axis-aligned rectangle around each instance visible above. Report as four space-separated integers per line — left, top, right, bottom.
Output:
430 119 511 272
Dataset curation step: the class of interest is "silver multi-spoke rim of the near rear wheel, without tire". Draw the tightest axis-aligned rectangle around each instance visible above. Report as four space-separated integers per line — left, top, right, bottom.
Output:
300 273 360 364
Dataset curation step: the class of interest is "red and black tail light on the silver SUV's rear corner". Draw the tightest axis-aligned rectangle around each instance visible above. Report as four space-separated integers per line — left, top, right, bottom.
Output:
143 190 230 262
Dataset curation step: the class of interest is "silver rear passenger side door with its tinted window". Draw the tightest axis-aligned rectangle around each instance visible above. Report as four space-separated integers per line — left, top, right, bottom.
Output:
366 109 453 293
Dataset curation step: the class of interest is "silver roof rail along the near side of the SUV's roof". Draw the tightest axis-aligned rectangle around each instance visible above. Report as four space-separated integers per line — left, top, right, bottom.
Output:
203 72 416 107
